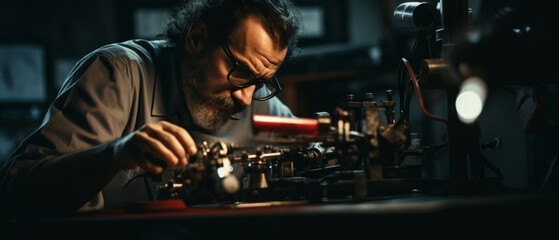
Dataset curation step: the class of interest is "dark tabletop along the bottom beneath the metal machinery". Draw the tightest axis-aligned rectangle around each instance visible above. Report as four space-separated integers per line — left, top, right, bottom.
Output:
7 193 559 239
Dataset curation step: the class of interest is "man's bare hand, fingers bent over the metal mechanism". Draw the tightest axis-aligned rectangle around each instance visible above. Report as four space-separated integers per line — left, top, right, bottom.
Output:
114 121 198 174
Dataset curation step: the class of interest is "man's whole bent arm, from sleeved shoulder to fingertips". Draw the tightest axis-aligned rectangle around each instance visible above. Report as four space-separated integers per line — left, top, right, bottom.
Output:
0 49 196 218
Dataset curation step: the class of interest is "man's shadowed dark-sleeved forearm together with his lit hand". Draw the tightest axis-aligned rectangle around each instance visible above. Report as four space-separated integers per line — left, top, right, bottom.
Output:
10 122 196 217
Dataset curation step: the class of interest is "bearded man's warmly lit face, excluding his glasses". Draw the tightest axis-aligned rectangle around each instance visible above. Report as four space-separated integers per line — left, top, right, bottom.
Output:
181 17 287 130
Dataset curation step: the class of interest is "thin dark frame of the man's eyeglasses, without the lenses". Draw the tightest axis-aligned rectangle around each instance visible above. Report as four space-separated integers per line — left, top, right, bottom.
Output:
221 43 282 101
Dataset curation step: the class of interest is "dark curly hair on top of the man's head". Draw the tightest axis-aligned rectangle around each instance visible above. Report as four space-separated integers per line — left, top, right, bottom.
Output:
163 0 300 55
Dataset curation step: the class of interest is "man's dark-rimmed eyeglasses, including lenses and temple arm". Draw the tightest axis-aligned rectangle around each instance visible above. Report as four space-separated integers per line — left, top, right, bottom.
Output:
222 44 281 101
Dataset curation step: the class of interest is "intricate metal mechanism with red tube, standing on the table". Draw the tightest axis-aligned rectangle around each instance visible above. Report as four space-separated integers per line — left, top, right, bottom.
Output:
153 81 508 206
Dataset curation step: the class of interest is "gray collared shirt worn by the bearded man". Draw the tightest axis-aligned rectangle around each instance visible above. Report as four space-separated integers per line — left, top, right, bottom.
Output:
0 40 293 210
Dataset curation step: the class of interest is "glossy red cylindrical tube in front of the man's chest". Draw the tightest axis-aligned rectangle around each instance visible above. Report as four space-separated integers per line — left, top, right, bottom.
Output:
252 114 319 136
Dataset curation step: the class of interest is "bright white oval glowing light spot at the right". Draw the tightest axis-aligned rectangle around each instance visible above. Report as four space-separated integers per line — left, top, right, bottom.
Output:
456 77 487 124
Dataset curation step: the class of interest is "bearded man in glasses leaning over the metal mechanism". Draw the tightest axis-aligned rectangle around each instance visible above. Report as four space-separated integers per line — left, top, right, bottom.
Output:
1 0 298 216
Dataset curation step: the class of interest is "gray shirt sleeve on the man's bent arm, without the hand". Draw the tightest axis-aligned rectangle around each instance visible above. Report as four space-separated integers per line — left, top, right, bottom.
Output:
0 48 135 212
